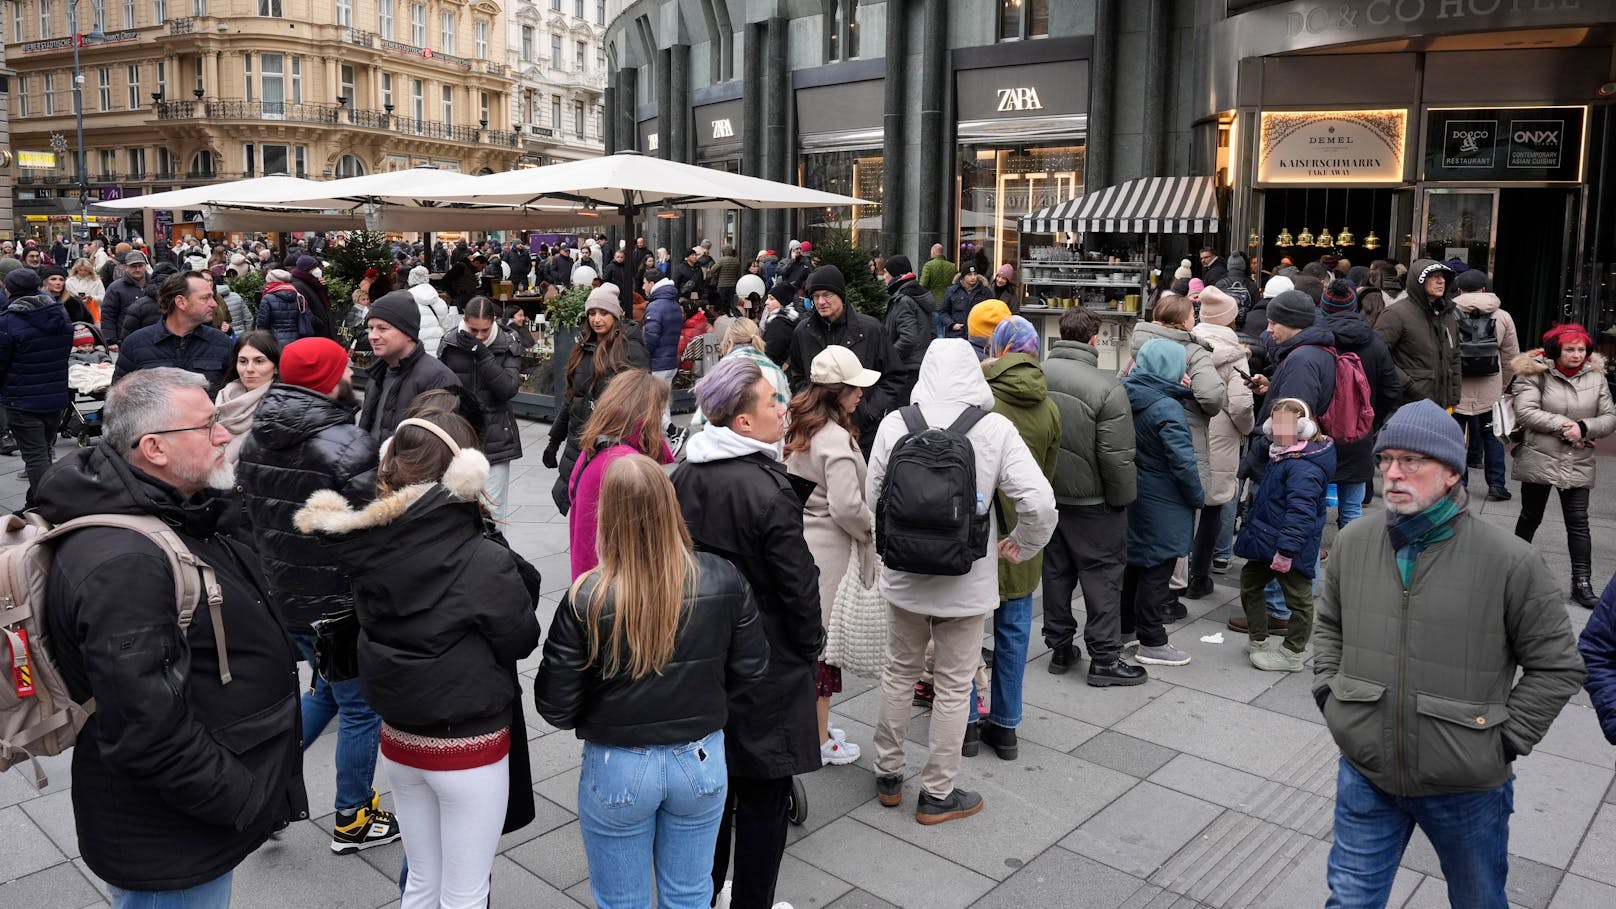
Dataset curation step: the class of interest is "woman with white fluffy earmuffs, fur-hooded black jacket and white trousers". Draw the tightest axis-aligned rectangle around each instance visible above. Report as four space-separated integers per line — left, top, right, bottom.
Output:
296 409 540 907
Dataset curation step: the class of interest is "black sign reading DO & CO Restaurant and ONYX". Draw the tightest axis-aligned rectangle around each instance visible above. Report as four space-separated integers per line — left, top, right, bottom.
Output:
1425 107 1587 183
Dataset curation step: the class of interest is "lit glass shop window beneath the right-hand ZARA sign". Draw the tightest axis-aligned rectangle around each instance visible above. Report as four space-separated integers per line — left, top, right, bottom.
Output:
955 141 1084 267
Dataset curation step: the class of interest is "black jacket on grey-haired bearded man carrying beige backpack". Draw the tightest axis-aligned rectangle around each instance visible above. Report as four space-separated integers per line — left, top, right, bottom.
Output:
36 445 309 890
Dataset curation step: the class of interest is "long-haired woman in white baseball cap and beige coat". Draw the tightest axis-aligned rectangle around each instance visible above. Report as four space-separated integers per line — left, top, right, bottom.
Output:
785 346 881 763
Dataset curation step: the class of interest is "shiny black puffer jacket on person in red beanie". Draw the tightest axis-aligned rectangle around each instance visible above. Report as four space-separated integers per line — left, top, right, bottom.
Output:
236 385 377 634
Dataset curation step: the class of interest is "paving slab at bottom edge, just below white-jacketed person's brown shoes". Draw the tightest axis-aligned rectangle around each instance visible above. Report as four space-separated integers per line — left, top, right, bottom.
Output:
790 815 994 909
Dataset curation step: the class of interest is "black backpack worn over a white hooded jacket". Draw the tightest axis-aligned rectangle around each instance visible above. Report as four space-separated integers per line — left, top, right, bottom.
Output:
876 404 987 576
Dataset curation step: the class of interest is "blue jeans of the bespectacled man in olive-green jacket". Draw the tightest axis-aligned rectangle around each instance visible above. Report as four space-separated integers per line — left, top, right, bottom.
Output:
1325 757 1514 909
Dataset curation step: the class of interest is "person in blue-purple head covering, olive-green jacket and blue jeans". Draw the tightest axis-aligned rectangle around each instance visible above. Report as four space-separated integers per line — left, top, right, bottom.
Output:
966 315 1060 760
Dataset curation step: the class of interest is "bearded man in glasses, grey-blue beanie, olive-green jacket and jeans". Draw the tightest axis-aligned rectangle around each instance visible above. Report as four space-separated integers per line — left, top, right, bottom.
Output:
1312 400 1585 907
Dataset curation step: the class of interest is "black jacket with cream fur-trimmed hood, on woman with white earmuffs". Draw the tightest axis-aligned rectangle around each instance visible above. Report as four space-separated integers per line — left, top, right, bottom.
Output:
296 465 538 741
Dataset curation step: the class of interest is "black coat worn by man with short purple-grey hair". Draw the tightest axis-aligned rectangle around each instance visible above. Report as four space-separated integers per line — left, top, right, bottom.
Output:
674 450 824 780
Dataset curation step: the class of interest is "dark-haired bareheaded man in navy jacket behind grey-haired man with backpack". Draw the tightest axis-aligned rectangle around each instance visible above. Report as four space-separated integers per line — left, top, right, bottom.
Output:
112 272 229 395
